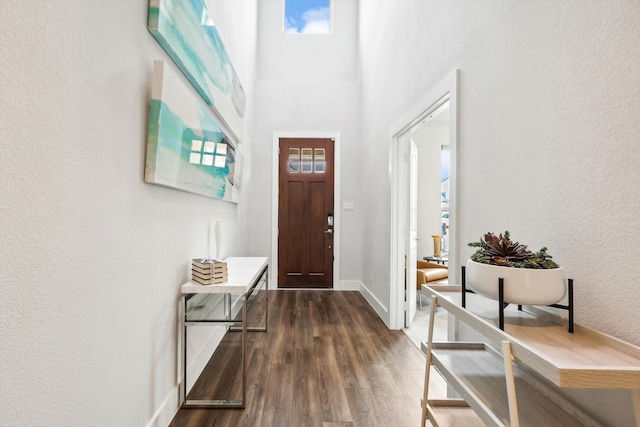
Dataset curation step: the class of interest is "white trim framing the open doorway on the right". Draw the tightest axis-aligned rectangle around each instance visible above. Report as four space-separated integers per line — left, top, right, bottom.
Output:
389 69 460 329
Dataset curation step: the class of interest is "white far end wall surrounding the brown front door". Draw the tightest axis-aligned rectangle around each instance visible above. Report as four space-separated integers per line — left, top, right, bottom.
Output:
249 0 366 289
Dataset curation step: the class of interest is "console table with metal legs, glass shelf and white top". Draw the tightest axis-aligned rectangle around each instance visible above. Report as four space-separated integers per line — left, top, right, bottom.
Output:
180 257 269 408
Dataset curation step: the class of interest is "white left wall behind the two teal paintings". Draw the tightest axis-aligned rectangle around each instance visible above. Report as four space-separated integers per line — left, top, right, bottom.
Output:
0 0 257 426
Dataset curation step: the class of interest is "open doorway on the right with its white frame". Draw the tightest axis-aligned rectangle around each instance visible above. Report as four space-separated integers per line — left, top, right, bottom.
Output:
389 70 459 329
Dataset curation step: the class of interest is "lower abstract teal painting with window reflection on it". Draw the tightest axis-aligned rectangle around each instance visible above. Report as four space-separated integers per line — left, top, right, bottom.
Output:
144 61 238 203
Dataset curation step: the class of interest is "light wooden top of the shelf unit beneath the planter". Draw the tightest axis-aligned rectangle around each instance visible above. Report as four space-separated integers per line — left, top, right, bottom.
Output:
423 286 640 389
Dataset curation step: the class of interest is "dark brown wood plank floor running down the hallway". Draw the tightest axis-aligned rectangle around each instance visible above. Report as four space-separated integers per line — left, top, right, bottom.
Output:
170 290 446 427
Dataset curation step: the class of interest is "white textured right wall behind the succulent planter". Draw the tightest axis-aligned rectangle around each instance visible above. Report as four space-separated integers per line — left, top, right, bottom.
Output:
360 0 640 426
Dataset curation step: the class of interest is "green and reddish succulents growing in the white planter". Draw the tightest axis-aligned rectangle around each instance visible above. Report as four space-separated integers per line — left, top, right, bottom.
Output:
468 231 560 269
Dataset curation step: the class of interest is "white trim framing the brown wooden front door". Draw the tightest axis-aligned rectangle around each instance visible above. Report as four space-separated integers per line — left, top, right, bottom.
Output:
269 132 342 290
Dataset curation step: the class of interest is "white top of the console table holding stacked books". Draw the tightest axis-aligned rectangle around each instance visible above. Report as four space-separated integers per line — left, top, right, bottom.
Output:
181 257 269 295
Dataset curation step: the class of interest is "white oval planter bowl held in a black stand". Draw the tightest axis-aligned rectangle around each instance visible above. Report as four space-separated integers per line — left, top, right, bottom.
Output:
465 260 567 305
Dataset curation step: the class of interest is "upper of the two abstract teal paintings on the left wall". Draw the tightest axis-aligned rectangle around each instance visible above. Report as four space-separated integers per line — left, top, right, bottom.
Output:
148 0 246 142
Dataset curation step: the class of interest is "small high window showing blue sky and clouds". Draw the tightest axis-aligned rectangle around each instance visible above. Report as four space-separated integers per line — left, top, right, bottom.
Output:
284 0 332 34
